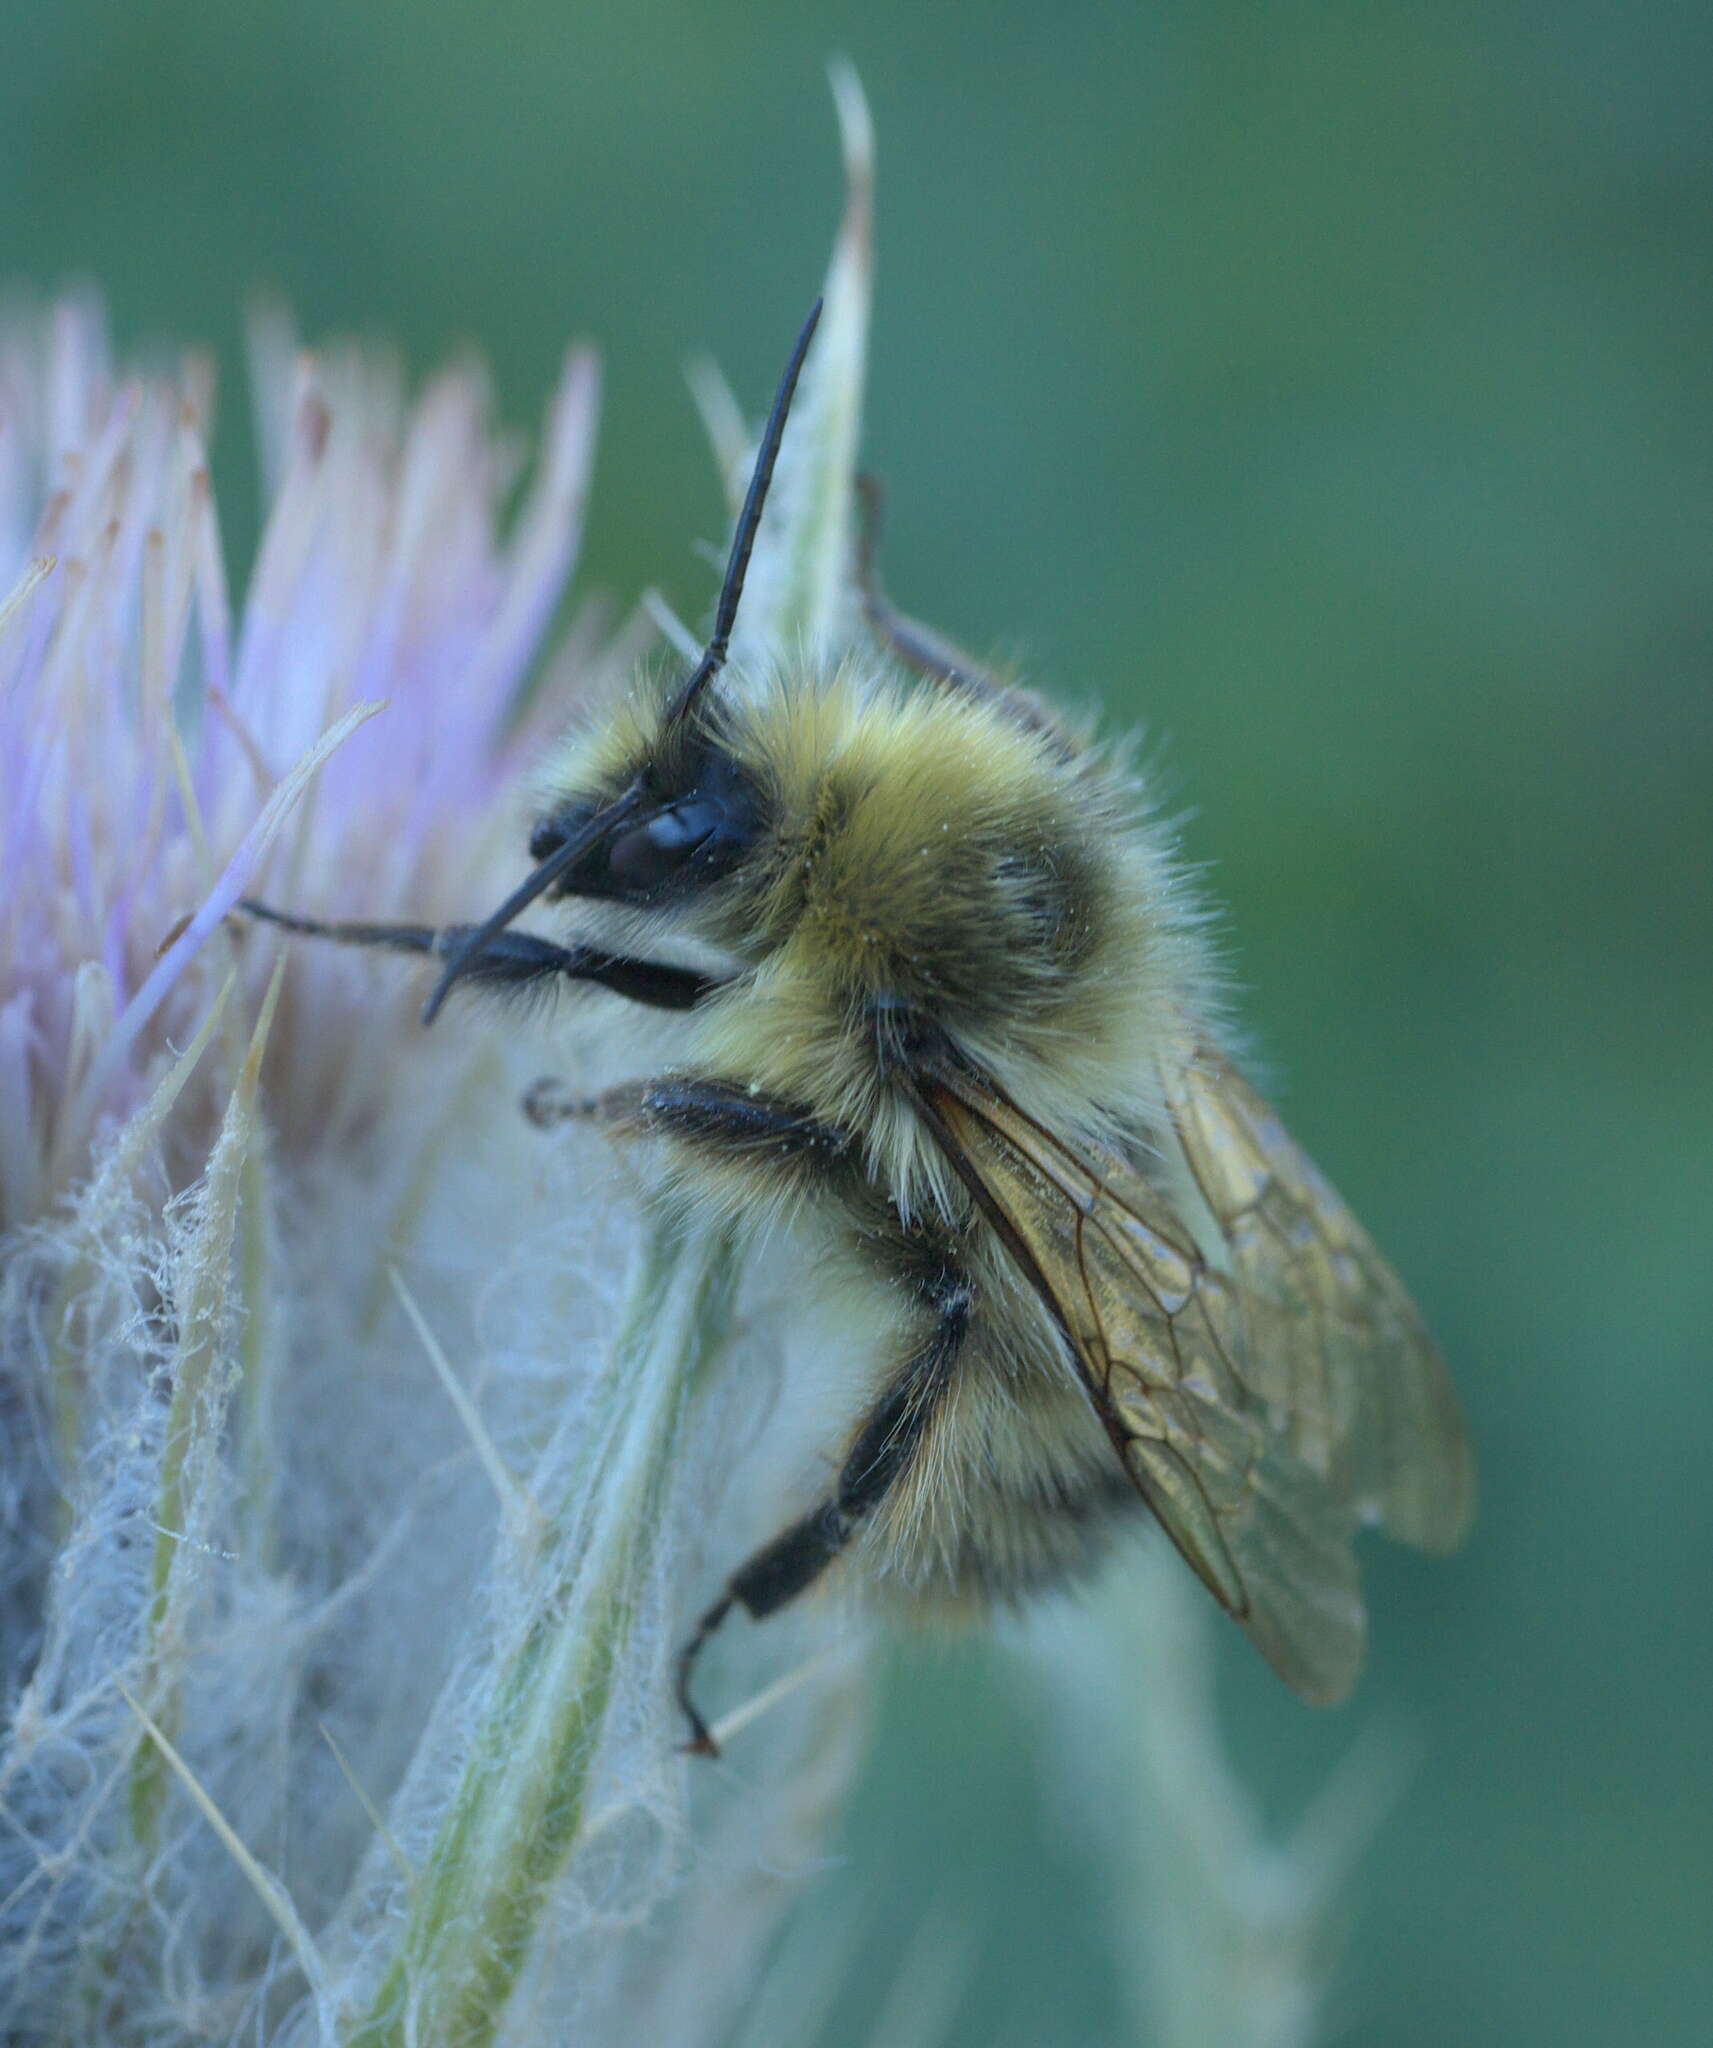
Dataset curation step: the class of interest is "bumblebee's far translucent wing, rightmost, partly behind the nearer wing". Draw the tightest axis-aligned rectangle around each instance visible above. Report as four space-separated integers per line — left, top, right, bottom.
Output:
1168 1053 1475 1550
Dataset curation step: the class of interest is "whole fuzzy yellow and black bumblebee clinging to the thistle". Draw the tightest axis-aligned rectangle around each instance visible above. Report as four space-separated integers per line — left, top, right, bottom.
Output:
248 309 1473 1753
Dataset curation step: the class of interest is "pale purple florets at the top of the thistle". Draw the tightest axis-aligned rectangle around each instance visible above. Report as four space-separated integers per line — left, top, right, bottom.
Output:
0 282 598 1229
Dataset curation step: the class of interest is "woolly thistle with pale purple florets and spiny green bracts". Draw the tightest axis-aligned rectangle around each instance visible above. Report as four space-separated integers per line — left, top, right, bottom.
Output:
0 75 867 2042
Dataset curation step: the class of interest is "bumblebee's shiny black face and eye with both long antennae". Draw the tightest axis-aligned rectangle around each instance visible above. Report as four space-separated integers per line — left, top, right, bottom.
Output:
422 299 822 1024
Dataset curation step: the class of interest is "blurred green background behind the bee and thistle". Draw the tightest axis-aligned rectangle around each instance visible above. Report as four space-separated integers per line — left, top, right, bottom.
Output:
0 0 1713 2048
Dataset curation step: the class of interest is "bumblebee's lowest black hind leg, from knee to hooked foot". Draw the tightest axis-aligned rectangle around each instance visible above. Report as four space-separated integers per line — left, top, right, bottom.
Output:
678 1257 971 1757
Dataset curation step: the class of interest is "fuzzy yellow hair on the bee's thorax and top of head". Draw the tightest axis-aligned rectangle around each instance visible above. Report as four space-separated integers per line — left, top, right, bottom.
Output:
551 662 1217 1217
